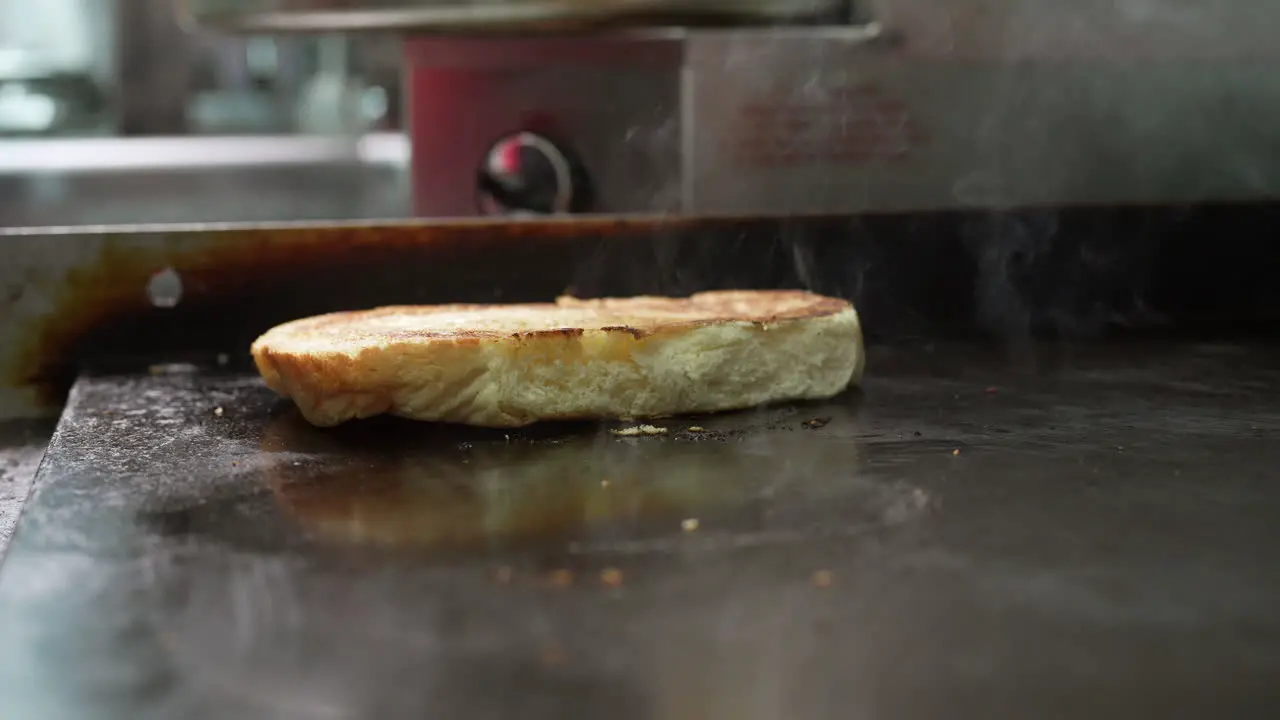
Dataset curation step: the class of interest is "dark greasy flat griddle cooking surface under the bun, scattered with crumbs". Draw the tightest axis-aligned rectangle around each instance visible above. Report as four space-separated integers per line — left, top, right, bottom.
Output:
0 346 1280 719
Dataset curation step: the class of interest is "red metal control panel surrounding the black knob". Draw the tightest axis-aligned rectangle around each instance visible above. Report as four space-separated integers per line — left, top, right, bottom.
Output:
407 33 685 217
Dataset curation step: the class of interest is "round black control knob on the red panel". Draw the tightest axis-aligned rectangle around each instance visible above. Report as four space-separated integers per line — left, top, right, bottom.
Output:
476 132 589 215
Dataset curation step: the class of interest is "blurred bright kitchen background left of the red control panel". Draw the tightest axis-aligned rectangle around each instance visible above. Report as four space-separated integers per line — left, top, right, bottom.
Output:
0 0 411 227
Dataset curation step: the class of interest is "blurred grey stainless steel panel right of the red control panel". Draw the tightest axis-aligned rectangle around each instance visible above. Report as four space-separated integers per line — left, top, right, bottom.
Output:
684 0 1280 213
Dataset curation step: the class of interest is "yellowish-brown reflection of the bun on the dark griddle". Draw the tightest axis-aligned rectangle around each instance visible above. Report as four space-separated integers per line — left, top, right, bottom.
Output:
254 397 900 552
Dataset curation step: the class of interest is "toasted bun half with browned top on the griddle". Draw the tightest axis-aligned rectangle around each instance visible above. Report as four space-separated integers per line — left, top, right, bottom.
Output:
252 291 864 428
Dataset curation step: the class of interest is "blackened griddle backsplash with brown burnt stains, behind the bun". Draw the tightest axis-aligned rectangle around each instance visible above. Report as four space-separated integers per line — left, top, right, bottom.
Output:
10 198 1280 417
